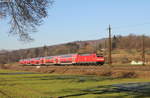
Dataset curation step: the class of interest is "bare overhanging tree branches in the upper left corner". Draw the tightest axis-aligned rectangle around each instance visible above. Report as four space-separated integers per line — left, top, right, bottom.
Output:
0 0 53 41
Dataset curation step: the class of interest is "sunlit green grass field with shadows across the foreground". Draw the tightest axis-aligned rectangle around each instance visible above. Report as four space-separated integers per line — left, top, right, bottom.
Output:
0 70 150 98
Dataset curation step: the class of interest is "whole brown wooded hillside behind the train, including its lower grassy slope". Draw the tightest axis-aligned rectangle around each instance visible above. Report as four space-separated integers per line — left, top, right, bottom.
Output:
0 34 150 64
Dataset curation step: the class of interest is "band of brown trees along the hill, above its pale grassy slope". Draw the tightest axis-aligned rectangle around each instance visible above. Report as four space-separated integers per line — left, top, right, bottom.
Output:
0 34 150 64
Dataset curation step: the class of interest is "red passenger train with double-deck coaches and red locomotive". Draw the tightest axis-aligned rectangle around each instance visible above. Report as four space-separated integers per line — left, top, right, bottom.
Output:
19 53 105 65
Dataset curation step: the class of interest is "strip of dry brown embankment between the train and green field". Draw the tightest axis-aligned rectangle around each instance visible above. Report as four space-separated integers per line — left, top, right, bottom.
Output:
1 65 150 78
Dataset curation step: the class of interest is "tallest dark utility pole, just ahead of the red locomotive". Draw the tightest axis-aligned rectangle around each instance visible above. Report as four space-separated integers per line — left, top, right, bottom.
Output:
108 25 112 65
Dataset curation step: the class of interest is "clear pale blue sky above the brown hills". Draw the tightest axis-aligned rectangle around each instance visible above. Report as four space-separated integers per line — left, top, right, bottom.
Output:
0 0 150 50
